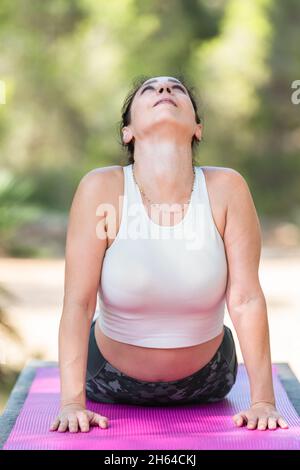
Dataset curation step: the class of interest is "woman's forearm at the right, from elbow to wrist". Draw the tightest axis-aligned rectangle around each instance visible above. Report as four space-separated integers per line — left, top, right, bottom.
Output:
230 295 275 404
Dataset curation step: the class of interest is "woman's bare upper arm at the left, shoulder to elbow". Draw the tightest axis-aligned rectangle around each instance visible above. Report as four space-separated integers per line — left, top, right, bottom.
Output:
64 169 108 315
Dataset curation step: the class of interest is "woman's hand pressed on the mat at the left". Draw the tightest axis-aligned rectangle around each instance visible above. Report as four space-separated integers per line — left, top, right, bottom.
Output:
50 403 108 432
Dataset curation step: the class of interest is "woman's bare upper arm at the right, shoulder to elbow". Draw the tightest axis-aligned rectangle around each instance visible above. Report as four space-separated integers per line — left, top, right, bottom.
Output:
224 170 262 313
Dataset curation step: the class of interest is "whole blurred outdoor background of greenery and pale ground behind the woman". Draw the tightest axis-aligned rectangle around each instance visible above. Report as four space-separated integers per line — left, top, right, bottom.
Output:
0 0 300 412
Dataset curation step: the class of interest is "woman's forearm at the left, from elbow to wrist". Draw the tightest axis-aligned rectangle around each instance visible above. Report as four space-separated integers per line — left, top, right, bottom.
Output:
59 304 92 406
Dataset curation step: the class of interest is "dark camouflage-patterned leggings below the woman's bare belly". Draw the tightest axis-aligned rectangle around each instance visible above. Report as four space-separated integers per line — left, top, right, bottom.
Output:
86 320 238 406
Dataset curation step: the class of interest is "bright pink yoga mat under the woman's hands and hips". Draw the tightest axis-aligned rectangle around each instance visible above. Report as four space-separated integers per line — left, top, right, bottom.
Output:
3 365 300 450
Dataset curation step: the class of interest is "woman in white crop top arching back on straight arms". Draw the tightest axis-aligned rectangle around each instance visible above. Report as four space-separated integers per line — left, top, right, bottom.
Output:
50 77 287 432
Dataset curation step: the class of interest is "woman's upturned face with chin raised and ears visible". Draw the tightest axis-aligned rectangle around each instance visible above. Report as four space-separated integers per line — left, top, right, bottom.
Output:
124 77 202 142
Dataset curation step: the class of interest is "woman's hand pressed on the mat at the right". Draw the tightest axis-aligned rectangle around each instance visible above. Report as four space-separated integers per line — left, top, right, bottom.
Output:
233 402 288 431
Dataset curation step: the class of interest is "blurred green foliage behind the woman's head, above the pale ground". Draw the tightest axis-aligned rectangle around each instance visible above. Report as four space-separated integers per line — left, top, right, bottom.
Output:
0 0 300 238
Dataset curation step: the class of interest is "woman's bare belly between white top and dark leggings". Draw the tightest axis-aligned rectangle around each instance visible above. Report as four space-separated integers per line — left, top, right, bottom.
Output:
95 321 224 382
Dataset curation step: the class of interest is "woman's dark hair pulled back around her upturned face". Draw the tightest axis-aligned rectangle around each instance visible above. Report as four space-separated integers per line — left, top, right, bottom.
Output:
119 74 201 164
